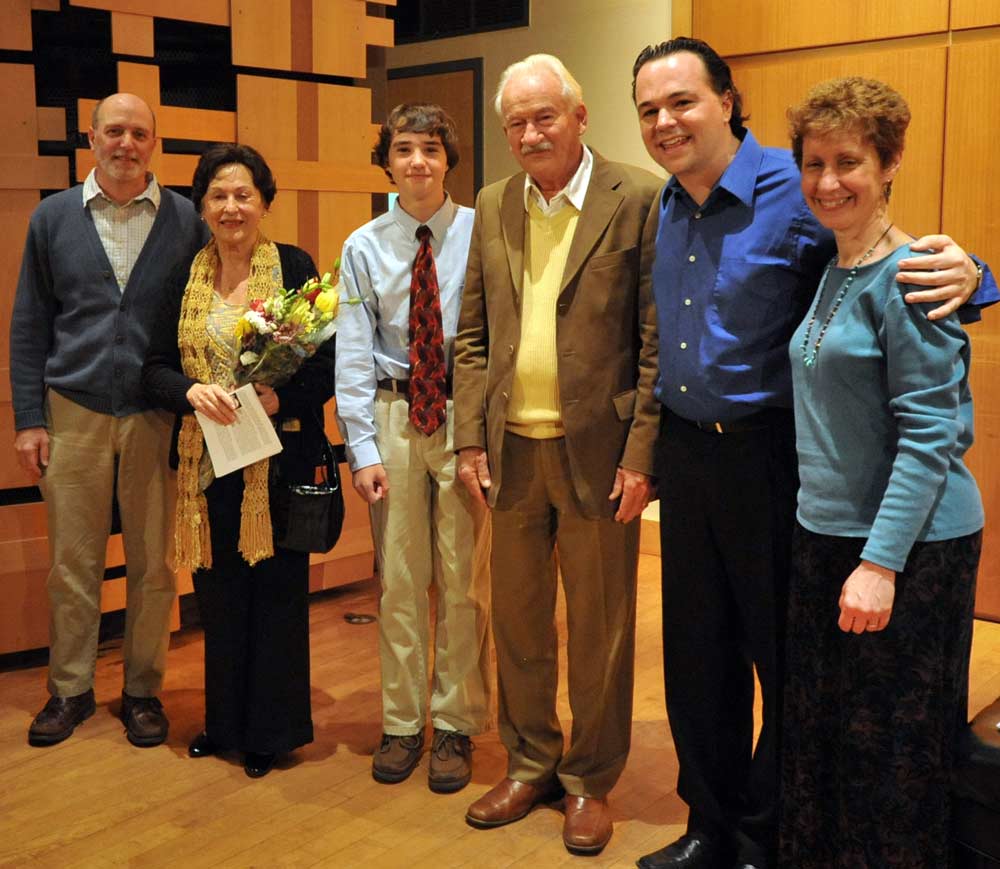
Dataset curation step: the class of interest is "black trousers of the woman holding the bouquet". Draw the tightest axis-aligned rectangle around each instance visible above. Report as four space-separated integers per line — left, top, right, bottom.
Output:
193 471 313 754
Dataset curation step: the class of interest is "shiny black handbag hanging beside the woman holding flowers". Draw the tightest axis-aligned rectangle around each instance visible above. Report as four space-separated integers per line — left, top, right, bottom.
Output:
271 435 344 552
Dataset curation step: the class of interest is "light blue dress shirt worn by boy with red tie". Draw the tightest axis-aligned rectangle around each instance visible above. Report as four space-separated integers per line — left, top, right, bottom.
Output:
336 196 475 471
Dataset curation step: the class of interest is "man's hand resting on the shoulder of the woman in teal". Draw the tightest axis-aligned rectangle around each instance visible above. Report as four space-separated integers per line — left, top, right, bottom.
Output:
897 235 979 320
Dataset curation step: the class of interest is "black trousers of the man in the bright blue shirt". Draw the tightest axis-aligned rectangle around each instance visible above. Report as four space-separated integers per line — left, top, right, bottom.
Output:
657 411 798 866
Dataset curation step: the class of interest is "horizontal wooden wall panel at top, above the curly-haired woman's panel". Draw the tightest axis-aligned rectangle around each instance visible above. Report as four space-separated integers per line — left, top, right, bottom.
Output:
692 0 948 56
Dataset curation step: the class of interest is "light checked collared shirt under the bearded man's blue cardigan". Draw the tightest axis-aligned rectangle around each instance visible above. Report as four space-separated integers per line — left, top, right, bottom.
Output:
83 169 160 292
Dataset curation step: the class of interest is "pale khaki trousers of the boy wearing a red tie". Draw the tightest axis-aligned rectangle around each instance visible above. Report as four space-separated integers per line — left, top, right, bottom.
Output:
371 390 490 736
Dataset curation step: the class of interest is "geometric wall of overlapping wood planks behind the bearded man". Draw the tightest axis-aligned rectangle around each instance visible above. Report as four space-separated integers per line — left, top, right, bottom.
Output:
0 0 396 655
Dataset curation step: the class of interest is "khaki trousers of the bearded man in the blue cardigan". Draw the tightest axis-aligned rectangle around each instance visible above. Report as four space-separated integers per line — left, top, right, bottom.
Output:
39 390 176 697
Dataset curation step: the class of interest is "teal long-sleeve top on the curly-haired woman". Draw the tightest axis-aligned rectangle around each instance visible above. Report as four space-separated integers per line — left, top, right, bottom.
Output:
789 245 983 571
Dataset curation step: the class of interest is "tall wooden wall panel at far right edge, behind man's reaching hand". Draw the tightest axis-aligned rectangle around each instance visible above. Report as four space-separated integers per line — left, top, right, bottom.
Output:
942 33 1000 618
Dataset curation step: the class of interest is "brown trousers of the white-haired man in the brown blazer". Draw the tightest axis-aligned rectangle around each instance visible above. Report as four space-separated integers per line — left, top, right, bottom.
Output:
492 432 639 797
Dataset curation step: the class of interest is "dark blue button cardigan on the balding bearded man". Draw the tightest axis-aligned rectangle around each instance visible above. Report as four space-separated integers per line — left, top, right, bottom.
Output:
10 185 207 430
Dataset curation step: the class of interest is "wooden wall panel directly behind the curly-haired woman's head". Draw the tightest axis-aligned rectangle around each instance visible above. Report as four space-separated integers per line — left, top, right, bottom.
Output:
730 40 947 235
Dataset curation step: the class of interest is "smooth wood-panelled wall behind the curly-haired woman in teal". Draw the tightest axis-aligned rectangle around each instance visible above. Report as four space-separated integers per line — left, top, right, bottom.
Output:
673 0 1000 620
